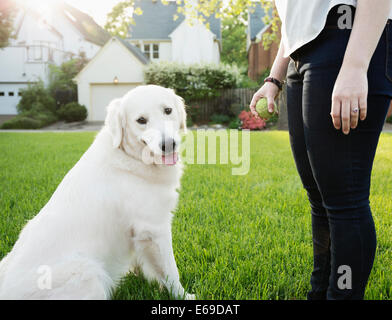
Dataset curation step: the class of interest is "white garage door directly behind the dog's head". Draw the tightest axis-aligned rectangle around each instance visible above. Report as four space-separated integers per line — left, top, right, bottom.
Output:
89 83 138 121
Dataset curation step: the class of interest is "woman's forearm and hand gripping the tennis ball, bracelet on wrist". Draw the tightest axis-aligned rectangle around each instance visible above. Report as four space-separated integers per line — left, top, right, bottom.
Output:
250 42 290 117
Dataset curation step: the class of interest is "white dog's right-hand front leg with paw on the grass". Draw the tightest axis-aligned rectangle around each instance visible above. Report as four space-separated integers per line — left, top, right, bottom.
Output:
137 233 195 300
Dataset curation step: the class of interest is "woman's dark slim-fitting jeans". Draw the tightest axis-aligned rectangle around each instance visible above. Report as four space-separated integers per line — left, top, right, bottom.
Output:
287 8 392 299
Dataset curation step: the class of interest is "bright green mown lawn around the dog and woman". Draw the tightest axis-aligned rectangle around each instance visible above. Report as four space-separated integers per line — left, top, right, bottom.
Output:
0 132 392 299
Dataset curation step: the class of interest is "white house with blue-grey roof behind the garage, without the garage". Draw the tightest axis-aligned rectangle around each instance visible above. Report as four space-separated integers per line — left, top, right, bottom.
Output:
127 0 222 64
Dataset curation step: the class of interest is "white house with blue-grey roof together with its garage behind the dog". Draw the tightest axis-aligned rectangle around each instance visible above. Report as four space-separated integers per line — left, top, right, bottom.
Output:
75 0 221 121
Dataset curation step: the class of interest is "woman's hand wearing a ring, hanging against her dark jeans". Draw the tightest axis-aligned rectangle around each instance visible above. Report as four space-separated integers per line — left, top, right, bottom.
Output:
331 65 368 134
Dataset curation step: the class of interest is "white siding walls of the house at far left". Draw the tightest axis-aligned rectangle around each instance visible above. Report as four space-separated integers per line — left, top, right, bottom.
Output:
0 6 106 115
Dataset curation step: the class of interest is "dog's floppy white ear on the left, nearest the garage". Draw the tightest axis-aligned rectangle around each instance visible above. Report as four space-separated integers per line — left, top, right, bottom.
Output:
105 99 125 148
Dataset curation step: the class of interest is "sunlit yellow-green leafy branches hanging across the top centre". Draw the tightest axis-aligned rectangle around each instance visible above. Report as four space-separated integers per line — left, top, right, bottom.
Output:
105 0 279 48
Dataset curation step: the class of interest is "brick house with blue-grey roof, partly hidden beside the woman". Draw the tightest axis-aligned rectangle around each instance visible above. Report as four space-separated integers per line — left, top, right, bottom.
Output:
246 2 279 81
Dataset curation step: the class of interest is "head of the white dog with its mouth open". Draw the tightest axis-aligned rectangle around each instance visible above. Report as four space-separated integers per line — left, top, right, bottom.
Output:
105 85 186 165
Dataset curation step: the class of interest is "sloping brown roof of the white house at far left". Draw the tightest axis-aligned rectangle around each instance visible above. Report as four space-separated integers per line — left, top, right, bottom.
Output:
58 3 110 46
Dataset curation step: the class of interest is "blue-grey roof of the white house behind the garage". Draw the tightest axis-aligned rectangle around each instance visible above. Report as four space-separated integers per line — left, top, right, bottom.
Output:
129 0 222 40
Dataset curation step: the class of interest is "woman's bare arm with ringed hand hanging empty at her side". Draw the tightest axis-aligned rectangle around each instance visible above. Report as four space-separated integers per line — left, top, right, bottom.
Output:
331 0 392 134
